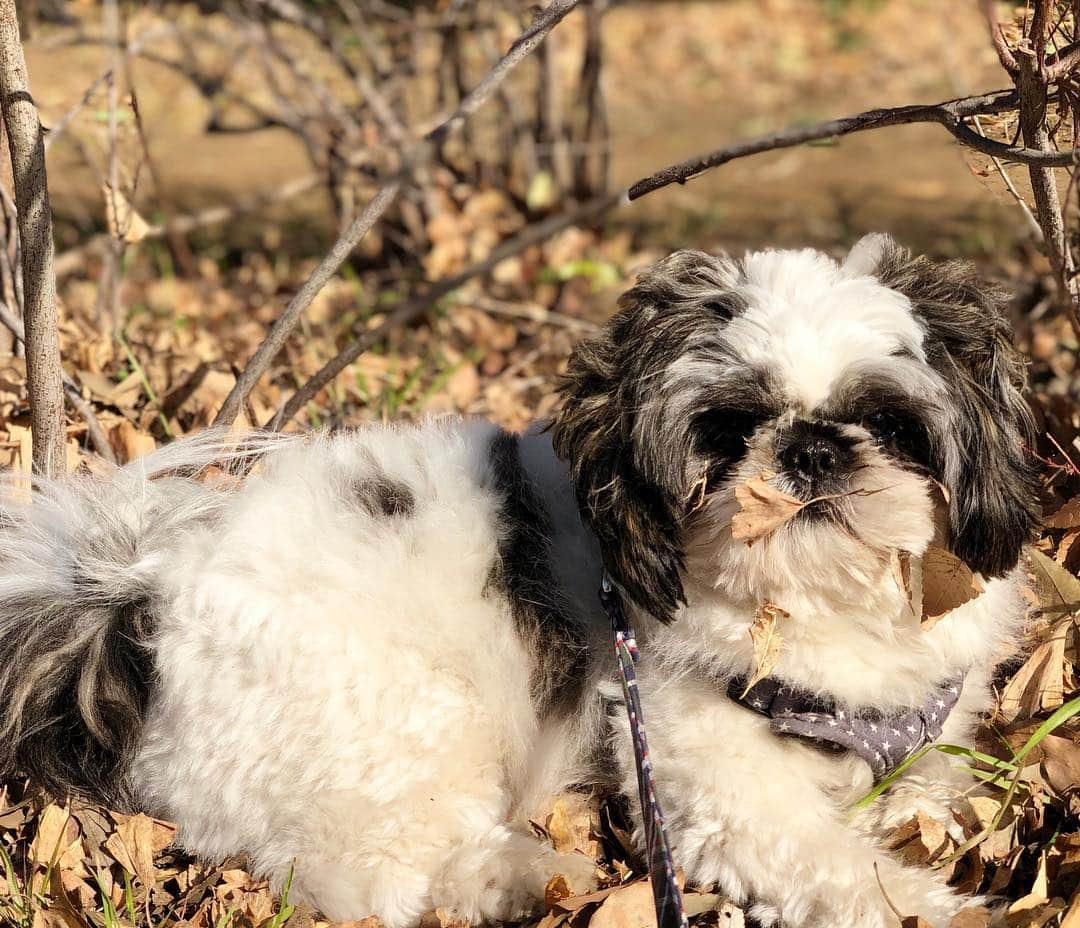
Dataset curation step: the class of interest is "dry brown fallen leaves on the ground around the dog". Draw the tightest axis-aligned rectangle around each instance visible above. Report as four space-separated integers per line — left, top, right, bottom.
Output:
0 226 1080 928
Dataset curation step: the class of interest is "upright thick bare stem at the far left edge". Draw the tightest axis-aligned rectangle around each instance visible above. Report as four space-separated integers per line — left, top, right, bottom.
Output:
0 0 67 478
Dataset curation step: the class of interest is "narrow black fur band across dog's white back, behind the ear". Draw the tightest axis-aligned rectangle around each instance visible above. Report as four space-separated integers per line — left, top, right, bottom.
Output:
488 431 588 715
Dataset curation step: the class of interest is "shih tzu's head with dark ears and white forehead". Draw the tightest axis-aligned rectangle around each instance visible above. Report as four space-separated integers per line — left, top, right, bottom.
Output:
554 236 1038 620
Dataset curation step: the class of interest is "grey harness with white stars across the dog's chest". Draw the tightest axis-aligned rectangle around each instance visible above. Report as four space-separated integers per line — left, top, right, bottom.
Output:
728 674 964 781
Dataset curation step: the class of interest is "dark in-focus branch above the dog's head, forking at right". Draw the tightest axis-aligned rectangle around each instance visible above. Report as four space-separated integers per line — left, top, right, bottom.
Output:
630 91 1075 200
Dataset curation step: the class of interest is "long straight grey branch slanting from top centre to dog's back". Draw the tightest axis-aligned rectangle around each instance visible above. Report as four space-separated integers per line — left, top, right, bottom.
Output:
210 0 578 426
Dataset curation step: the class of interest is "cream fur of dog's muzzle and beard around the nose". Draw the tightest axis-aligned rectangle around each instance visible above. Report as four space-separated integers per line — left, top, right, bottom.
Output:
687 430 940 608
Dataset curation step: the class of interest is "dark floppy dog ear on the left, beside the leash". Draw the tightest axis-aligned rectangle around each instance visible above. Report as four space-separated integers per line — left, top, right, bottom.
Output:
552 251 731 622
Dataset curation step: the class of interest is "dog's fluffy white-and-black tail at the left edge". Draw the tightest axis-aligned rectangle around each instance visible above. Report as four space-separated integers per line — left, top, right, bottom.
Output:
0 432 287 806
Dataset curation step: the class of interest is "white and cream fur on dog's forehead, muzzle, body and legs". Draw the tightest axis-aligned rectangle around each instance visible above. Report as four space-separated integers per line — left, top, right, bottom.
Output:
4 243 1022 928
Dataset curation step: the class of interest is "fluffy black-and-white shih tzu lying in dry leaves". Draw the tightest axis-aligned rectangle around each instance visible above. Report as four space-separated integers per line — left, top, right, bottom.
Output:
0 236 1038 928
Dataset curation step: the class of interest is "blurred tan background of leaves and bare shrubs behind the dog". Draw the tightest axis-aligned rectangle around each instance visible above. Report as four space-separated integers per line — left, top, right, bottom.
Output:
6 0 1054 457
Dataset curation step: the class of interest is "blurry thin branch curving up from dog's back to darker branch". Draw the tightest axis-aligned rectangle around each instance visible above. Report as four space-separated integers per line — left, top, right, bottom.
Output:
266 191 626 431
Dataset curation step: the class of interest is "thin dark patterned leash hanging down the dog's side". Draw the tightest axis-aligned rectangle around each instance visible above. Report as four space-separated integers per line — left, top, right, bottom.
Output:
600 574 688 928
